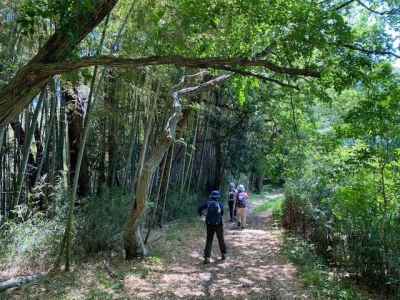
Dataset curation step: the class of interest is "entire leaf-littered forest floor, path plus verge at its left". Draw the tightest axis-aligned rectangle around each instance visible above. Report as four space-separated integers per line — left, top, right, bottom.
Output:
0 191 310 299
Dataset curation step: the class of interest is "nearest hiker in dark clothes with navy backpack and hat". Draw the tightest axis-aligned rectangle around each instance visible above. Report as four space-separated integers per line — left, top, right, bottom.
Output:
198 191 226 264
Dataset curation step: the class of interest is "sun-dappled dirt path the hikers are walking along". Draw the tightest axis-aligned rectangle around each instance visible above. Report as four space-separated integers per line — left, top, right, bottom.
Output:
124 191 308 299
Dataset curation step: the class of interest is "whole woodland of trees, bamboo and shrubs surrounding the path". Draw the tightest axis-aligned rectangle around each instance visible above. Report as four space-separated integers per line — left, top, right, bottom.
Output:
0 0 400 295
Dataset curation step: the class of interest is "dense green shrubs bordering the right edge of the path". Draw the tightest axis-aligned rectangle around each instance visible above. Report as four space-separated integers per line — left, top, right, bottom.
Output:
282 145 400 294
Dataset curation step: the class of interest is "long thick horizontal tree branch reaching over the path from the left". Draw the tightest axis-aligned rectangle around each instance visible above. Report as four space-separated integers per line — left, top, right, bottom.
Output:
0 56 321 124
